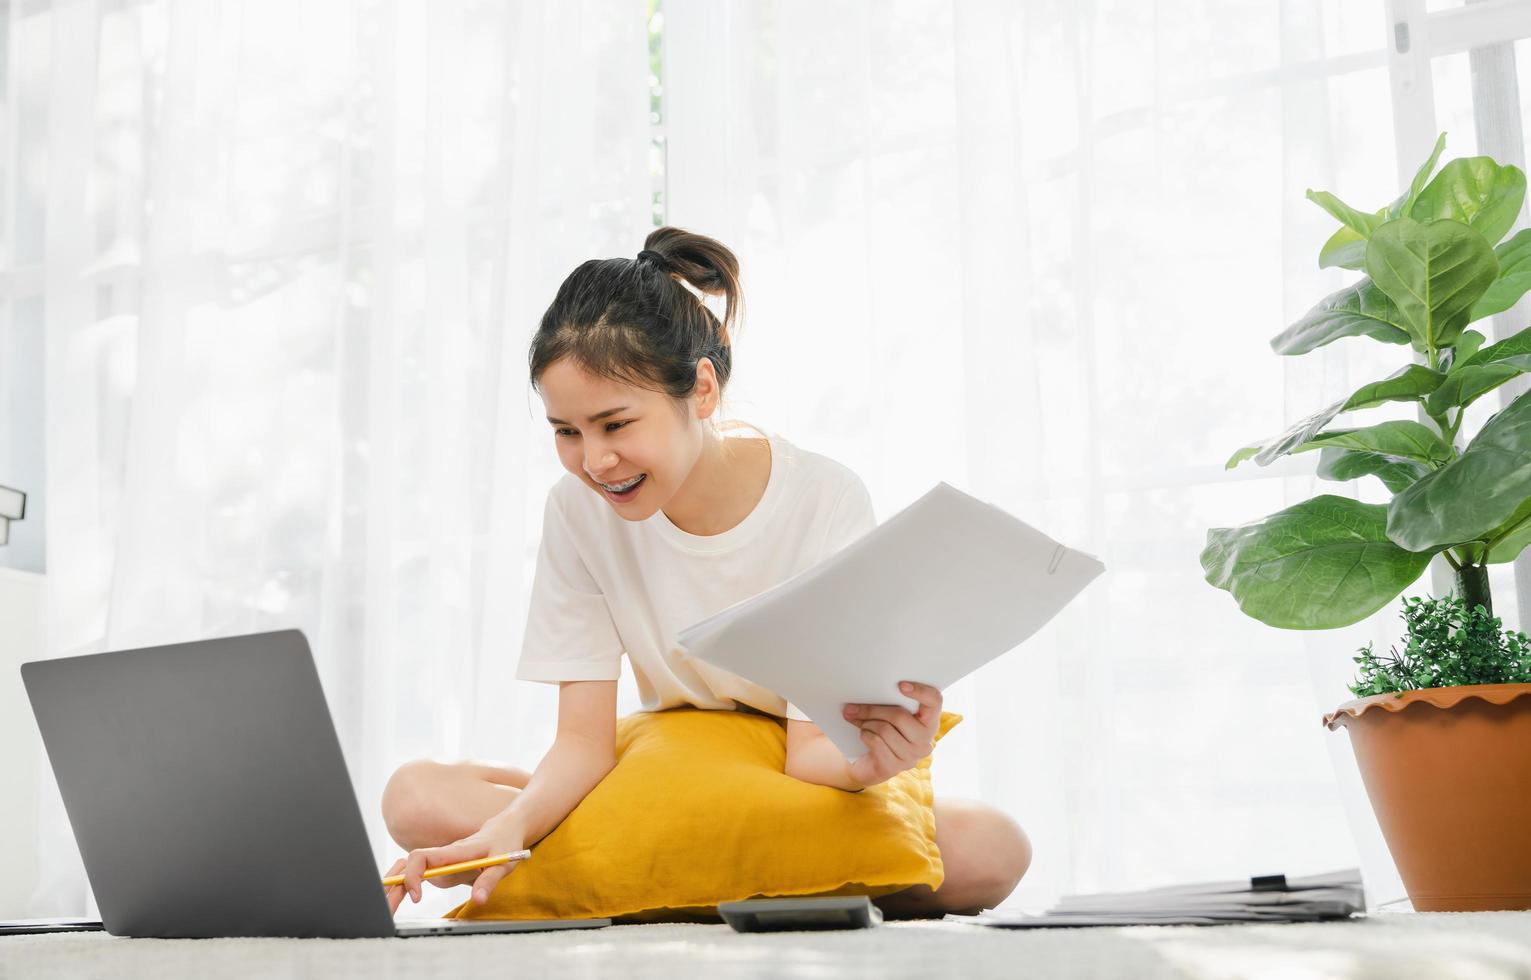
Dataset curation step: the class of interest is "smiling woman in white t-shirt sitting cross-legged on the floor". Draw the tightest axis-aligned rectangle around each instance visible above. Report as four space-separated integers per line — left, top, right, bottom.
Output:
384 228 1030 916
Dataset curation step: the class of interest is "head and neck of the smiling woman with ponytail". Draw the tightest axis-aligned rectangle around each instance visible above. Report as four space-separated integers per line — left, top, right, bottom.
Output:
530 228 770 534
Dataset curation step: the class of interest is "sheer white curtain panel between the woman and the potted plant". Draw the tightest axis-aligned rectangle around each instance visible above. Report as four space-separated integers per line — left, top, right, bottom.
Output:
664 0 1445 905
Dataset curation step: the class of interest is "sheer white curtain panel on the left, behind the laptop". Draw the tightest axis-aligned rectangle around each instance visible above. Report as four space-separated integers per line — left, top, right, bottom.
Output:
22 0 652 914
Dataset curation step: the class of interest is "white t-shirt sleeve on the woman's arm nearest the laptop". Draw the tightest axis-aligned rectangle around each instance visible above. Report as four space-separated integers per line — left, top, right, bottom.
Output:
516 492 622 683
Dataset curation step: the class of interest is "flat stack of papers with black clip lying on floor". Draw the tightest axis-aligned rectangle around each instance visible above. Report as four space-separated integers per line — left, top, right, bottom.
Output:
946 868 1366 929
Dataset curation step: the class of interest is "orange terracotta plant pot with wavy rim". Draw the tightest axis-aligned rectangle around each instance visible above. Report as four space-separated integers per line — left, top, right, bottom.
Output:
1324 684 1531 913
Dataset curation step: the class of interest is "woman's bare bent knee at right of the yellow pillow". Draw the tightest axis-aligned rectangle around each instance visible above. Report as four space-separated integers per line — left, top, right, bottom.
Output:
873 799 1032 919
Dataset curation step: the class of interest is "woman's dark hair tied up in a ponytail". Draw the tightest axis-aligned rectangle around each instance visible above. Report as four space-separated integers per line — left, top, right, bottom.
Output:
528 227 744 401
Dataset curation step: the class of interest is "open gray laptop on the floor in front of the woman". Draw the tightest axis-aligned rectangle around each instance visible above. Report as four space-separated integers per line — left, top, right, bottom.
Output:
21 629 611 939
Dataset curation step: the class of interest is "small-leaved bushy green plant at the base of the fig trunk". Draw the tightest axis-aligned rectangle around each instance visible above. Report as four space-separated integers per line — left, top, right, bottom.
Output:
1350 594 1531 698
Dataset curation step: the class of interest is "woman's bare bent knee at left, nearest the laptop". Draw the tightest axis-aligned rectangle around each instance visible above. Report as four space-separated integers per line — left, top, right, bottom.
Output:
383 760 531 850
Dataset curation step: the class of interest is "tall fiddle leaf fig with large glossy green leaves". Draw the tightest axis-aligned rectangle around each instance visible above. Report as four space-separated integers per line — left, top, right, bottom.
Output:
1202 133 1531 629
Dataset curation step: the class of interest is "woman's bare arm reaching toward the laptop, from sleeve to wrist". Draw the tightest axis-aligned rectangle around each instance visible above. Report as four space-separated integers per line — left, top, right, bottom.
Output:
490 680 617 847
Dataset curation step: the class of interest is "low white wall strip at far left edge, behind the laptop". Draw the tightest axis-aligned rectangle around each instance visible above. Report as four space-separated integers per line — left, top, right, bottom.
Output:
0 568 46 919
